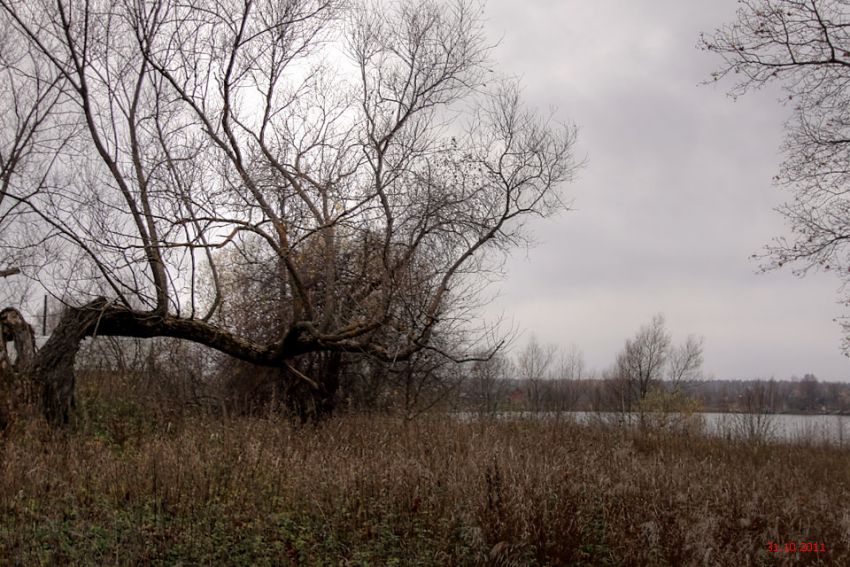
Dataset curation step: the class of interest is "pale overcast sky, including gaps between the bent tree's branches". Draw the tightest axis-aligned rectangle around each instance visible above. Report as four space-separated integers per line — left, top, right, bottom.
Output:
0 0 850 386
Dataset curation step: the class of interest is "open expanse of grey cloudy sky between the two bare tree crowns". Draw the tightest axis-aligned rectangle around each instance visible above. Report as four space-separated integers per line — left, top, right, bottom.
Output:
480 0 850 380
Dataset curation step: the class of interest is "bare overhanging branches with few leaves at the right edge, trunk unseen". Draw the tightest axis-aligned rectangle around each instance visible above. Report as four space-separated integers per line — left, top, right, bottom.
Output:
702 0 850 351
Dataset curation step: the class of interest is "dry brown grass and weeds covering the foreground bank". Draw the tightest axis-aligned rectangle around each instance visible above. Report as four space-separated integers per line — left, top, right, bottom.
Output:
0 390 850 566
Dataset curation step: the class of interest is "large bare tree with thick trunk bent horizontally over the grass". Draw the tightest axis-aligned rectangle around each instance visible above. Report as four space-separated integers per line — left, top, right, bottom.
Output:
0 0 576 419
